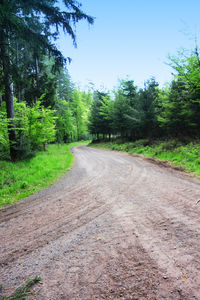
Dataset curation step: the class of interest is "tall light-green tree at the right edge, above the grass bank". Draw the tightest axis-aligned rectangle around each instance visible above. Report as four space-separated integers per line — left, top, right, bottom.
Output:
166 47 200 136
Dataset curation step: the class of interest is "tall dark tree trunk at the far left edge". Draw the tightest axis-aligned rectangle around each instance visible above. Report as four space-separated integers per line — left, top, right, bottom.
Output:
0 31 17 160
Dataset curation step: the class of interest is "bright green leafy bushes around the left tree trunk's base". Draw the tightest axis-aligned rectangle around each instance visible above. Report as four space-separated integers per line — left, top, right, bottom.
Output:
0 101 56 159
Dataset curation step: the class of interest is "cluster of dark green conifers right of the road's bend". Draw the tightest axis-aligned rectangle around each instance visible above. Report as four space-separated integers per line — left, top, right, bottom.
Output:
89 78 159 140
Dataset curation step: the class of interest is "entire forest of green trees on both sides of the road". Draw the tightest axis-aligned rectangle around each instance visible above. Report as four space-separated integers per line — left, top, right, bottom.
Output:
0 0 200 161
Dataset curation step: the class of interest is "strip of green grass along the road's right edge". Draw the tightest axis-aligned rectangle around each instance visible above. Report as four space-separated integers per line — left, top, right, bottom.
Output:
90 139 200 175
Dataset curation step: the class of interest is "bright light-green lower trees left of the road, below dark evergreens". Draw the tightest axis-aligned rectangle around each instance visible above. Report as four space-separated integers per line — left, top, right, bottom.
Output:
0 79 92 159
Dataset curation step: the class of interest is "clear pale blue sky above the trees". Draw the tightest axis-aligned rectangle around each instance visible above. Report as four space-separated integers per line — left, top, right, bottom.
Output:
58 0 200 90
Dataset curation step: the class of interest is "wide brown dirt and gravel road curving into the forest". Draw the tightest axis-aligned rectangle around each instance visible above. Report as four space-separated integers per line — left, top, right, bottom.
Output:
0 146 200 300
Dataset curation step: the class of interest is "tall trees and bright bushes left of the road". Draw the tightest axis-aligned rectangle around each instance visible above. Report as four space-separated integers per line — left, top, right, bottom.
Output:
0 0 93 160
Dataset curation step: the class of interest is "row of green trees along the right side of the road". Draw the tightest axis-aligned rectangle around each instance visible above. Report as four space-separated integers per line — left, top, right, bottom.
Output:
89 47 200 140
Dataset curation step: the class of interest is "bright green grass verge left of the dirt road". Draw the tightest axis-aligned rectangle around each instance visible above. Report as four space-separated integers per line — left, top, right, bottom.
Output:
0 142 87 207
